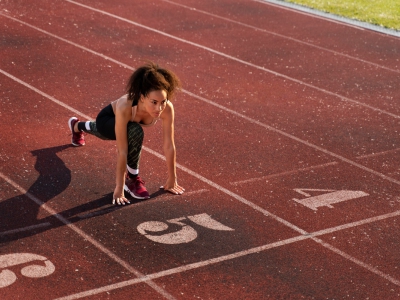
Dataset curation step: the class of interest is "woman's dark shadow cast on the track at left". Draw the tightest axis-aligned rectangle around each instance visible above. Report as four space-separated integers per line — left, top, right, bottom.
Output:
0 145 133 246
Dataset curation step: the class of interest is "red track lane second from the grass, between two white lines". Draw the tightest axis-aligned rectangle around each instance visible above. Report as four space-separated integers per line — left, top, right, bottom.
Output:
71 0 400 112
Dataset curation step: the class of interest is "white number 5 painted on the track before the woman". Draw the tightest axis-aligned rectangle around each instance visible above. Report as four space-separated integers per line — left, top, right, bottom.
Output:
137 213 234 245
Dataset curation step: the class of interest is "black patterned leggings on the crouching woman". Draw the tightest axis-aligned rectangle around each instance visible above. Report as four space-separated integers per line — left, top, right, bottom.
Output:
78 104 144 175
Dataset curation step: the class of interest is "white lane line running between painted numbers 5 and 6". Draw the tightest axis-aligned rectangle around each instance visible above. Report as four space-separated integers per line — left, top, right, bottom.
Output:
0 171 175 300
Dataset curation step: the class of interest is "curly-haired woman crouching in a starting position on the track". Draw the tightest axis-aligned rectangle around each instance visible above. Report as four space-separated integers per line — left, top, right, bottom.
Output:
68 62 185 205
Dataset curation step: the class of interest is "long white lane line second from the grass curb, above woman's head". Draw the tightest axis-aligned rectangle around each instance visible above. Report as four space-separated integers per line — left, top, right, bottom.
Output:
58 0 400 119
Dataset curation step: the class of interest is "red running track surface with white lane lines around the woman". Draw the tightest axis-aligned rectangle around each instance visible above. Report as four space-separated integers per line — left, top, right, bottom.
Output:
0 0 400 299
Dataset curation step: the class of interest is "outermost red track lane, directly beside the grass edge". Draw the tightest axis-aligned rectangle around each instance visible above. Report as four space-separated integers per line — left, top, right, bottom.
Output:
165 0 400 71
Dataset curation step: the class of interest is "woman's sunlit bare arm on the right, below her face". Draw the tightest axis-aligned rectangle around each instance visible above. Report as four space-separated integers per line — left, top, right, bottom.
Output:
161 102 185 194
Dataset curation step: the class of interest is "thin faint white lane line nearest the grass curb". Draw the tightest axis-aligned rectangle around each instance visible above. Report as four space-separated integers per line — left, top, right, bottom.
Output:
162 0 400 73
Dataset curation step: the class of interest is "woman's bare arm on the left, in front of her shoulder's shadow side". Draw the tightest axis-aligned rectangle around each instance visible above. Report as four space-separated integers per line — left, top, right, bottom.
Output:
113 99 132 204
